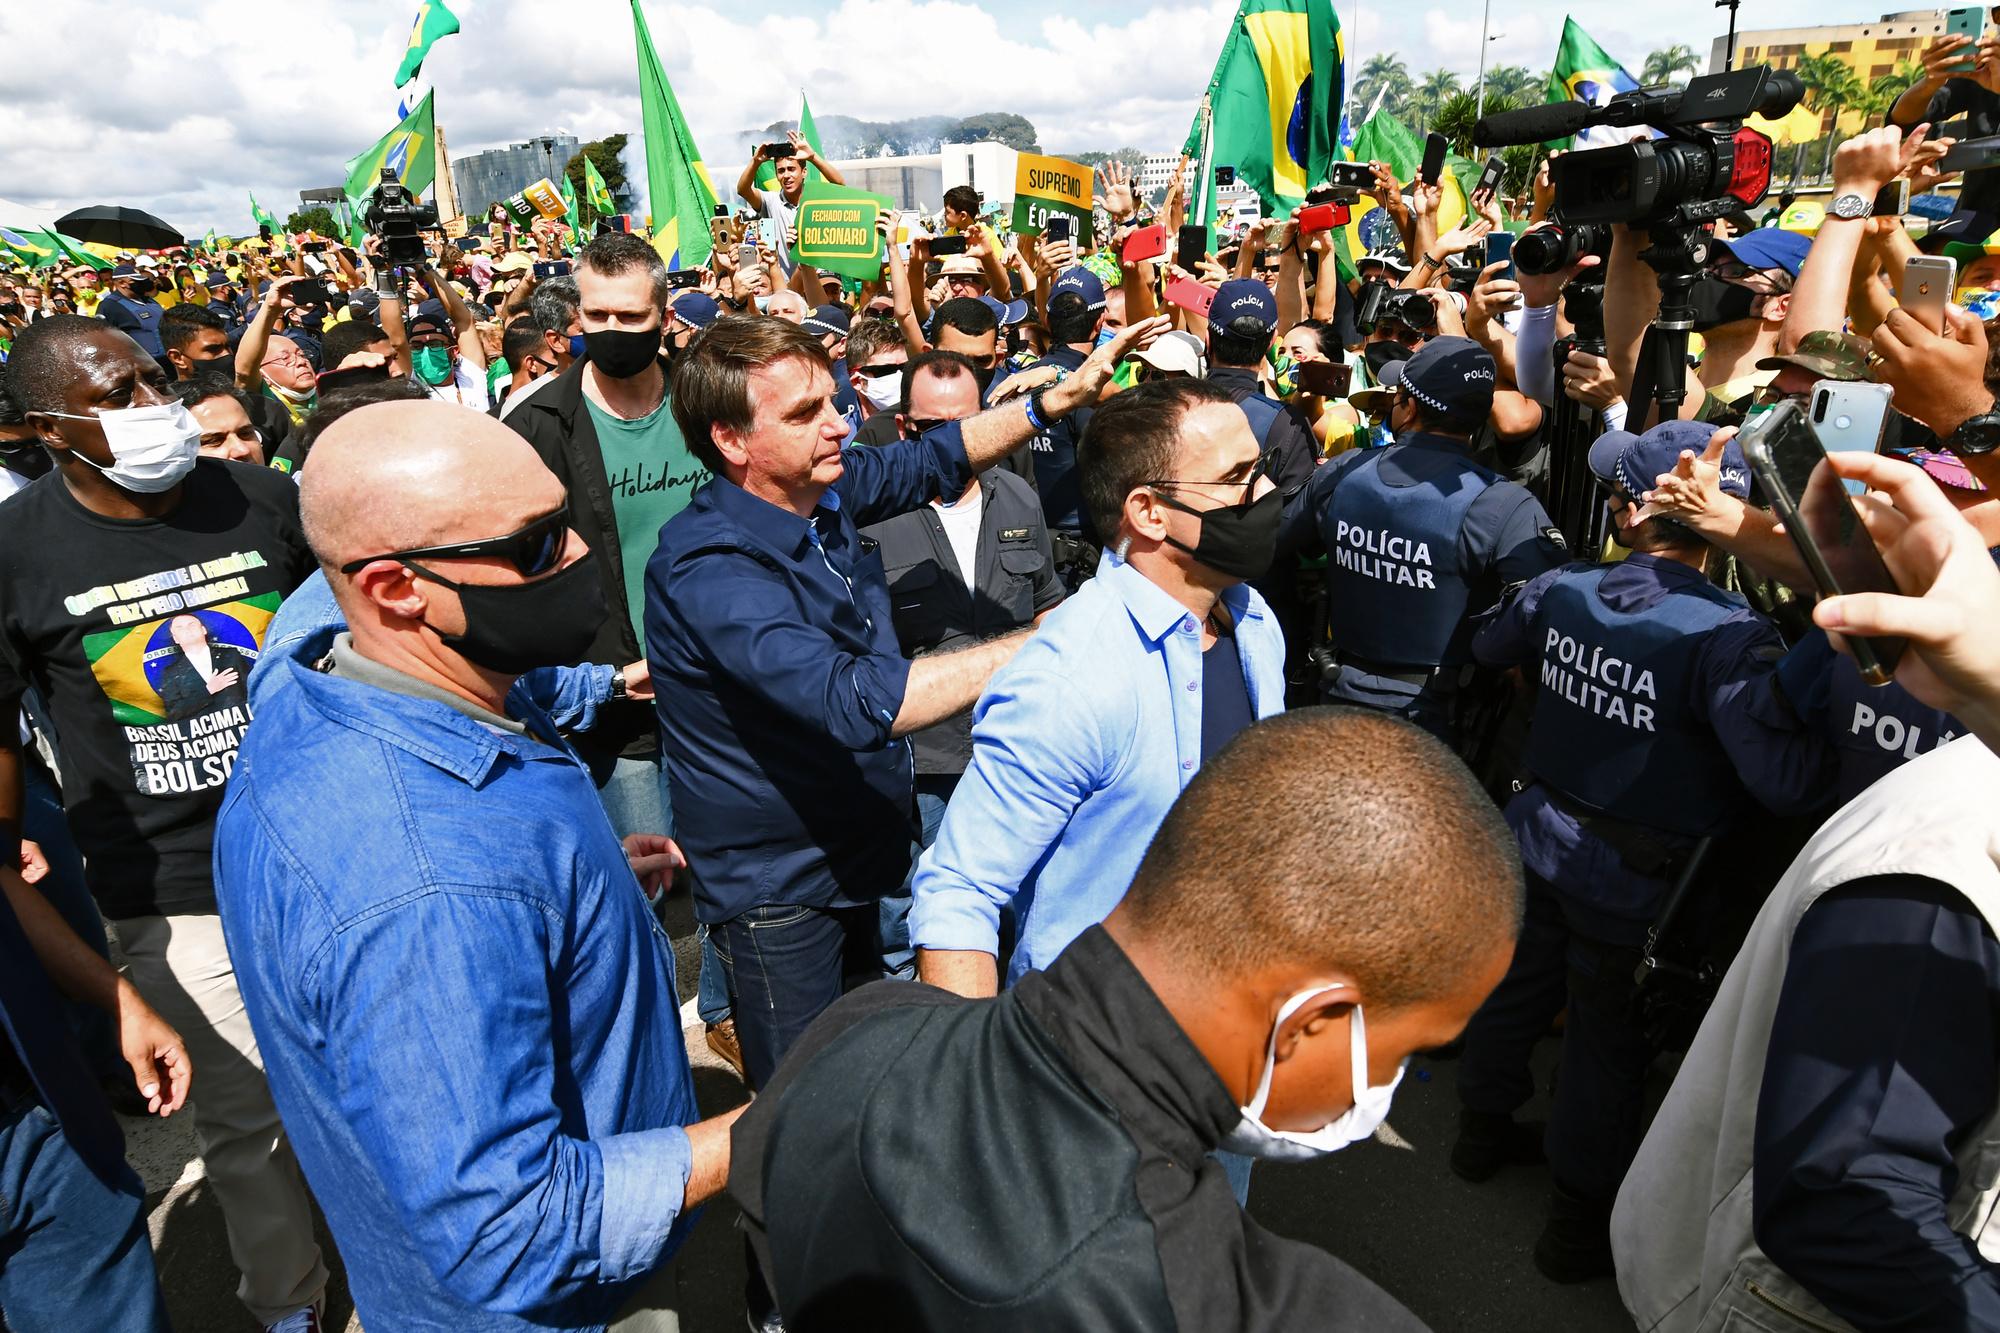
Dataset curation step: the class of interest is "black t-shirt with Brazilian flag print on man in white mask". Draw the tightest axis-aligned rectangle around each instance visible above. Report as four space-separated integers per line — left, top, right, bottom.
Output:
0 458 314 919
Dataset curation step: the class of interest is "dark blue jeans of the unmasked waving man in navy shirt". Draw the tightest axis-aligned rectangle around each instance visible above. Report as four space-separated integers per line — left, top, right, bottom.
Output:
708 903 882 1089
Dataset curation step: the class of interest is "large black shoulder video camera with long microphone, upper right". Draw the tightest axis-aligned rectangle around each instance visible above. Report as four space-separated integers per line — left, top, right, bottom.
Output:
1472 64 1806 228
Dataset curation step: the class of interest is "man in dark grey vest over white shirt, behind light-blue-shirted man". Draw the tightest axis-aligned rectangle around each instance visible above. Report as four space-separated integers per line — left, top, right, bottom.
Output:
862 352 1062 977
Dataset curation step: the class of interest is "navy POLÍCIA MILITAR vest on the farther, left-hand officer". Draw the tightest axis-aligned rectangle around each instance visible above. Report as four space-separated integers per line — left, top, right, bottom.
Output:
1320 450 1498 667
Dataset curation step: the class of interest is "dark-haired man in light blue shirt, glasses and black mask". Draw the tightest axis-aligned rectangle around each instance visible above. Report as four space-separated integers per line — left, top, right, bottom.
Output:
910 380 1284 997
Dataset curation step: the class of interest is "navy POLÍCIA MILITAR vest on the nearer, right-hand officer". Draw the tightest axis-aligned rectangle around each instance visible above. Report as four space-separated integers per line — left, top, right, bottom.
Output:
1526 564 1746 837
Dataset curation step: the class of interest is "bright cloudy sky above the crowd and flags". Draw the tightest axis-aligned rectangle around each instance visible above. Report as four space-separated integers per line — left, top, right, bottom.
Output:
0 0 1840 234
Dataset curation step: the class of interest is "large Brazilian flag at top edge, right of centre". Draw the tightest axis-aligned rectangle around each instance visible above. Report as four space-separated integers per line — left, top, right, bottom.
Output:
1182 0 1346 216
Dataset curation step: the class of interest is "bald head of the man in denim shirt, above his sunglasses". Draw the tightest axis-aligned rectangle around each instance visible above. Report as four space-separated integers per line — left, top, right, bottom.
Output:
298 402 564 576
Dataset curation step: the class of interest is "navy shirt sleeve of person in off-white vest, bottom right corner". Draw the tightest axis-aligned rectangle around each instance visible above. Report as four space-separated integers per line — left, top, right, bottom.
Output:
1754 875 2000 1333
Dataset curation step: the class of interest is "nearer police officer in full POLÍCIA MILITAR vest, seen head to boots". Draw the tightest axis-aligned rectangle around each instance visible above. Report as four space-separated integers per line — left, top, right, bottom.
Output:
1452 420 1826 1281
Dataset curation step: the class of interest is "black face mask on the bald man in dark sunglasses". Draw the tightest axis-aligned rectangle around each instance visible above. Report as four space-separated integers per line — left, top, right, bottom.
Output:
412 550 610 677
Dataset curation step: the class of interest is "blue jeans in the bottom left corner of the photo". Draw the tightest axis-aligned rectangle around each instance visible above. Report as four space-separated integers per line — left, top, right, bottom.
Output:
0 1105 168 1333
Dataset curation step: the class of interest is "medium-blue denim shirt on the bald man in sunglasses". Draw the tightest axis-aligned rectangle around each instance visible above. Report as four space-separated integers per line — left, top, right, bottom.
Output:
214 662 700 1331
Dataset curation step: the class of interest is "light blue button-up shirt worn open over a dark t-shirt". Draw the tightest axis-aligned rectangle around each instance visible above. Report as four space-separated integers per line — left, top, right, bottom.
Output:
910 552 1284 985
